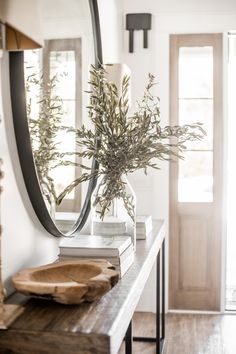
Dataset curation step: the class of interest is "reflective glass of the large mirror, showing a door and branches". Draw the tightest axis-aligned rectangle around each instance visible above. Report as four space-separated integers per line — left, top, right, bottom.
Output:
24 0 95 233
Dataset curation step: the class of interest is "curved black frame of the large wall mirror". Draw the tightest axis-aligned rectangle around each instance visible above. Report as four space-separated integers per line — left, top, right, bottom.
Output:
9 0 103 237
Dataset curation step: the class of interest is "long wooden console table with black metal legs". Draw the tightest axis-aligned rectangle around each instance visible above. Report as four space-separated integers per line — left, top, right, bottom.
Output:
0 221 165 354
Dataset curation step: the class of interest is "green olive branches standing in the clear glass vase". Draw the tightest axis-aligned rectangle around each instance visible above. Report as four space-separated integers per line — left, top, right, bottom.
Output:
57 66 206 220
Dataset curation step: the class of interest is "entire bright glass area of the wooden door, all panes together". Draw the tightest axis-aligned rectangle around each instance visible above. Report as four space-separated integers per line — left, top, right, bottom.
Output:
178 46 213 202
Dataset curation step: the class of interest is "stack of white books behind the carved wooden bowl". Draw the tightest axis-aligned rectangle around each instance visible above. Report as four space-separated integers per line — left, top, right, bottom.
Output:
59 235 134 277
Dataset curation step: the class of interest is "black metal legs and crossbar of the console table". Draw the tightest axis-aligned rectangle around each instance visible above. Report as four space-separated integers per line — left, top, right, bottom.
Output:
125 239 165 354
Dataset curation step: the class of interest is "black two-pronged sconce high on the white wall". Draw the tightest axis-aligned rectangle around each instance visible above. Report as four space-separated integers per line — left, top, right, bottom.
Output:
126 14 152 53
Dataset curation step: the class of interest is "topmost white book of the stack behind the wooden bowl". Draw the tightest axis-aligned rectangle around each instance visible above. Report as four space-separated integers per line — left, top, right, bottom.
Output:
59 235 131 258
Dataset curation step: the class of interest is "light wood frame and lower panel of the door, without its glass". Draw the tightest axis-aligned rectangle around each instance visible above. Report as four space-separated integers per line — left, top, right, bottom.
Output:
169 33 224 311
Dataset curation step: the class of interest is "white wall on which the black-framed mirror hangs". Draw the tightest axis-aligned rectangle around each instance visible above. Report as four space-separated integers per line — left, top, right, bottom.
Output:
0 0 121 293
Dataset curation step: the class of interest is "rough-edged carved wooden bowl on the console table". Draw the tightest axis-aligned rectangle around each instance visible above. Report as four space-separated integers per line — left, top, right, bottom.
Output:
12 260 119 304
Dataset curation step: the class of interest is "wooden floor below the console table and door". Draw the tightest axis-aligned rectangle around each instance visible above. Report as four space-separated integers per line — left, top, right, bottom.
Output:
119 312 236 354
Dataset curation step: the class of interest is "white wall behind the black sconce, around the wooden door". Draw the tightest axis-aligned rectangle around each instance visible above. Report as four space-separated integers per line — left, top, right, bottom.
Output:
122 0 236 311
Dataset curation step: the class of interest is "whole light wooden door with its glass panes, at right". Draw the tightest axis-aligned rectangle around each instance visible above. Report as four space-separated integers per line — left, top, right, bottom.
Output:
169 34 223 310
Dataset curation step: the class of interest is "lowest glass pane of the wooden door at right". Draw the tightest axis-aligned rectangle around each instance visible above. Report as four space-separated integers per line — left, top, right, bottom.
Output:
178 151 213 202
